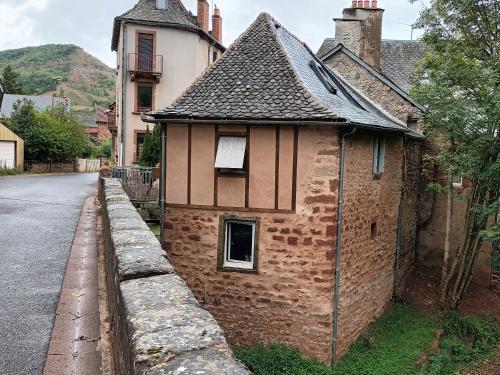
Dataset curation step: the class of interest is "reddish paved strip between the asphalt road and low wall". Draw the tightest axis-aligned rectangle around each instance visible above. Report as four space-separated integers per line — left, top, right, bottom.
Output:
44 196 102 375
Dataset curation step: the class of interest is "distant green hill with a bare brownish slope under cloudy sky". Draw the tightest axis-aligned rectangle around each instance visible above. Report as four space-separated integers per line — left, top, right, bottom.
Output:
0 44 115 110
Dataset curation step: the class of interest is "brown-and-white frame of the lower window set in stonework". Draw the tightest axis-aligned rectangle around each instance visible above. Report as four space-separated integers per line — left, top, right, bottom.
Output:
217 216 260 273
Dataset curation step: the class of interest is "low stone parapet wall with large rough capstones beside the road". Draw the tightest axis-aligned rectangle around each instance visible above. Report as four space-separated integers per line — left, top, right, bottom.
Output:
99 179 250 375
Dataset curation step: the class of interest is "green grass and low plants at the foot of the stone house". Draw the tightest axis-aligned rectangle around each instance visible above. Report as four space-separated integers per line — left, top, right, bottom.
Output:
235 305 500 375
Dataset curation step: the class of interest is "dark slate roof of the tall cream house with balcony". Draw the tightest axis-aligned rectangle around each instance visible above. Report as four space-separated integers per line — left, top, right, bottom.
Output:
111 0 224 51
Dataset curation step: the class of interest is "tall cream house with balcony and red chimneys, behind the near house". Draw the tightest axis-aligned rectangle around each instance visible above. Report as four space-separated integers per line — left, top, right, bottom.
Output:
111 0 224 166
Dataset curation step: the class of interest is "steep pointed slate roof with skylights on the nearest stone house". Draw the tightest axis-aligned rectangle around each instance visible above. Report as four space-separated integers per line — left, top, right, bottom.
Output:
152 13 418 131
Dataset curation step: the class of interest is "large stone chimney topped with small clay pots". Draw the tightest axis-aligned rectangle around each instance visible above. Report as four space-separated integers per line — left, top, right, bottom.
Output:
334 0 384 70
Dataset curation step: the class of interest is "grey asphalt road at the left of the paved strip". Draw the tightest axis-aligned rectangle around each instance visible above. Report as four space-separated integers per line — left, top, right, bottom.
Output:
0 174 97 375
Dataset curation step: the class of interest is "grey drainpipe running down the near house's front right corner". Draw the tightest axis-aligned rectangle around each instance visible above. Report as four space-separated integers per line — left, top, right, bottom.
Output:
332 128 357 364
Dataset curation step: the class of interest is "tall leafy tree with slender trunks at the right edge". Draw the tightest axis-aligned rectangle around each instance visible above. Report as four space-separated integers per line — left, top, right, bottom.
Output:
412 0 500 308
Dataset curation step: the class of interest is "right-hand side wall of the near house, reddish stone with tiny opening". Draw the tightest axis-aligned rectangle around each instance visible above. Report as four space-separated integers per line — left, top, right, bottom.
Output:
338 132 403 355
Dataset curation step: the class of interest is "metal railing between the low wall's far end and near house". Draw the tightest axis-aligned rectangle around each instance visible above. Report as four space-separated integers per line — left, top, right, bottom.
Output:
111 166 160 202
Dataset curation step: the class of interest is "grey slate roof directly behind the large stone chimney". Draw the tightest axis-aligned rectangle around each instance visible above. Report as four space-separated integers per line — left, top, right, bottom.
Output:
316 38 428 92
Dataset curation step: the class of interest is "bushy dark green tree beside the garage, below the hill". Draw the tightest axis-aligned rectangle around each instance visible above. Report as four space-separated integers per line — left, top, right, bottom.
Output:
9 100 90 163
